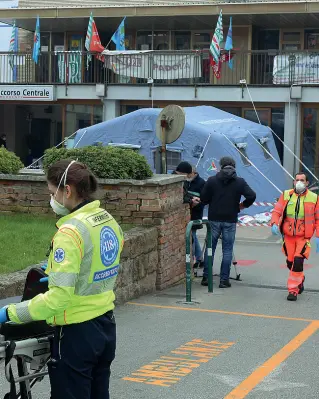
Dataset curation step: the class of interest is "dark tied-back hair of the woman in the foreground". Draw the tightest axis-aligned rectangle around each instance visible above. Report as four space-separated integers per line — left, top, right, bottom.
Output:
47 159 98 200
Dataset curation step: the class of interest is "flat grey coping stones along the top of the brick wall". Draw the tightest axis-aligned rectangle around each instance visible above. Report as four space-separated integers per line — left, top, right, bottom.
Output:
0 174 185 186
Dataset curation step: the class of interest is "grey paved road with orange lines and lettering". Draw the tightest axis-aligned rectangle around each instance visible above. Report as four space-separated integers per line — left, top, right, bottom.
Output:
0 227 319 399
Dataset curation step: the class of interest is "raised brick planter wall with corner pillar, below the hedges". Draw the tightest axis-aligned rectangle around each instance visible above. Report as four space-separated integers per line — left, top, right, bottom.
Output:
0 175 189 289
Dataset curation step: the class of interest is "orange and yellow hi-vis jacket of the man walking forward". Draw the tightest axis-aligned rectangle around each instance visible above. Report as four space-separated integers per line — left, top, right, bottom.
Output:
271 190 319 239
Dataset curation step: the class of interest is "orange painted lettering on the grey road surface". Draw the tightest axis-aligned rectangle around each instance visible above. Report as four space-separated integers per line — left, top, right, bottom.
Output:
123 339 235 387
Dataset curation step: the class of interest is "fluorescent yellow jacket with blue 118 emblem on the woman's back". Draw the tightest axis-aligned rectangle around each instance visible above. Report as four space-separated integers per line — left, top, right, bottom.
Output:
8 201 124 326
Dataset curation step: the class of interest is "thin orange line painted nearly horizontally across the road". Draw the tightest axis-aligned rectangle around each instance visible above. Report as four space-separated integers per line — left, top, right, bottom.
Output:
126 302 317 323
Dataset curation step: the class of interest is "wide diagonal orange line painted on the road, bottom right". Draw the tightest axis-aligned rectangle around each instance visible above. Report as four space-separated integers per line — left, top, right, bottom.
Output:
224 321 319 399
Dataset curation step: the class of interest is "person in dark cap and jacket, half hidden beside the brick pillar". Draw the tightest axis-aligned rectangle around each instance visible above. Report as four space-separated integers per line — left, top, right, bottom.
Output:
175 161 205 267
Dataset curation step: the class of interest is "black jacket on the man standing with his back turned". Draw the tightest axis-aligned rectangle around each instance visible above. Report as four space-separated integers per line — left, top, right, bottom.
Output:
200 166 256 223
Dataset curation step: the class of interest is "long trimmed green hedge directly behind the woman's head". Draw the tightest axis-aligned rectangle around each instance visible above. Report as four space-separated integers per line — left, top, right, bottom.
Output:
43 146 152 180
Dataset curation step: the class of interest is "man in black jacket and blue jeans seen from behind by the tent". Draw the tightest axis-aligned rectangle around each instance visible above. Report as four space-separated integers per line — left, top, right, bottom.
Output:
200 157 256 288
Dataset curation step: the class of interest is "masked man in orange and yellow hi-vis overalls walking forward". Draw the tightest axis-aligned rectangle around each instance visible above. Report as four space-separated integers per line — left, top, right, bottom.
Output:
271 173 319 301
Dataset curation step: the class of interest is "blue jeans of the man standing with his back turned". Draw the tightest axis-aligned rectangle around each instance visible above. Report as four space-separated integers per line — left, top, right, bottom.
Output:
203 222 236 281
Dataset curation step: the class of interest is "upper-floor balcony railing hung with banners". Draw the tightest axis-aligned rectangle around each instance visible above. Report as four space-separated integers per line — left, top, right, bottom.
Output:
0 50 319 86
